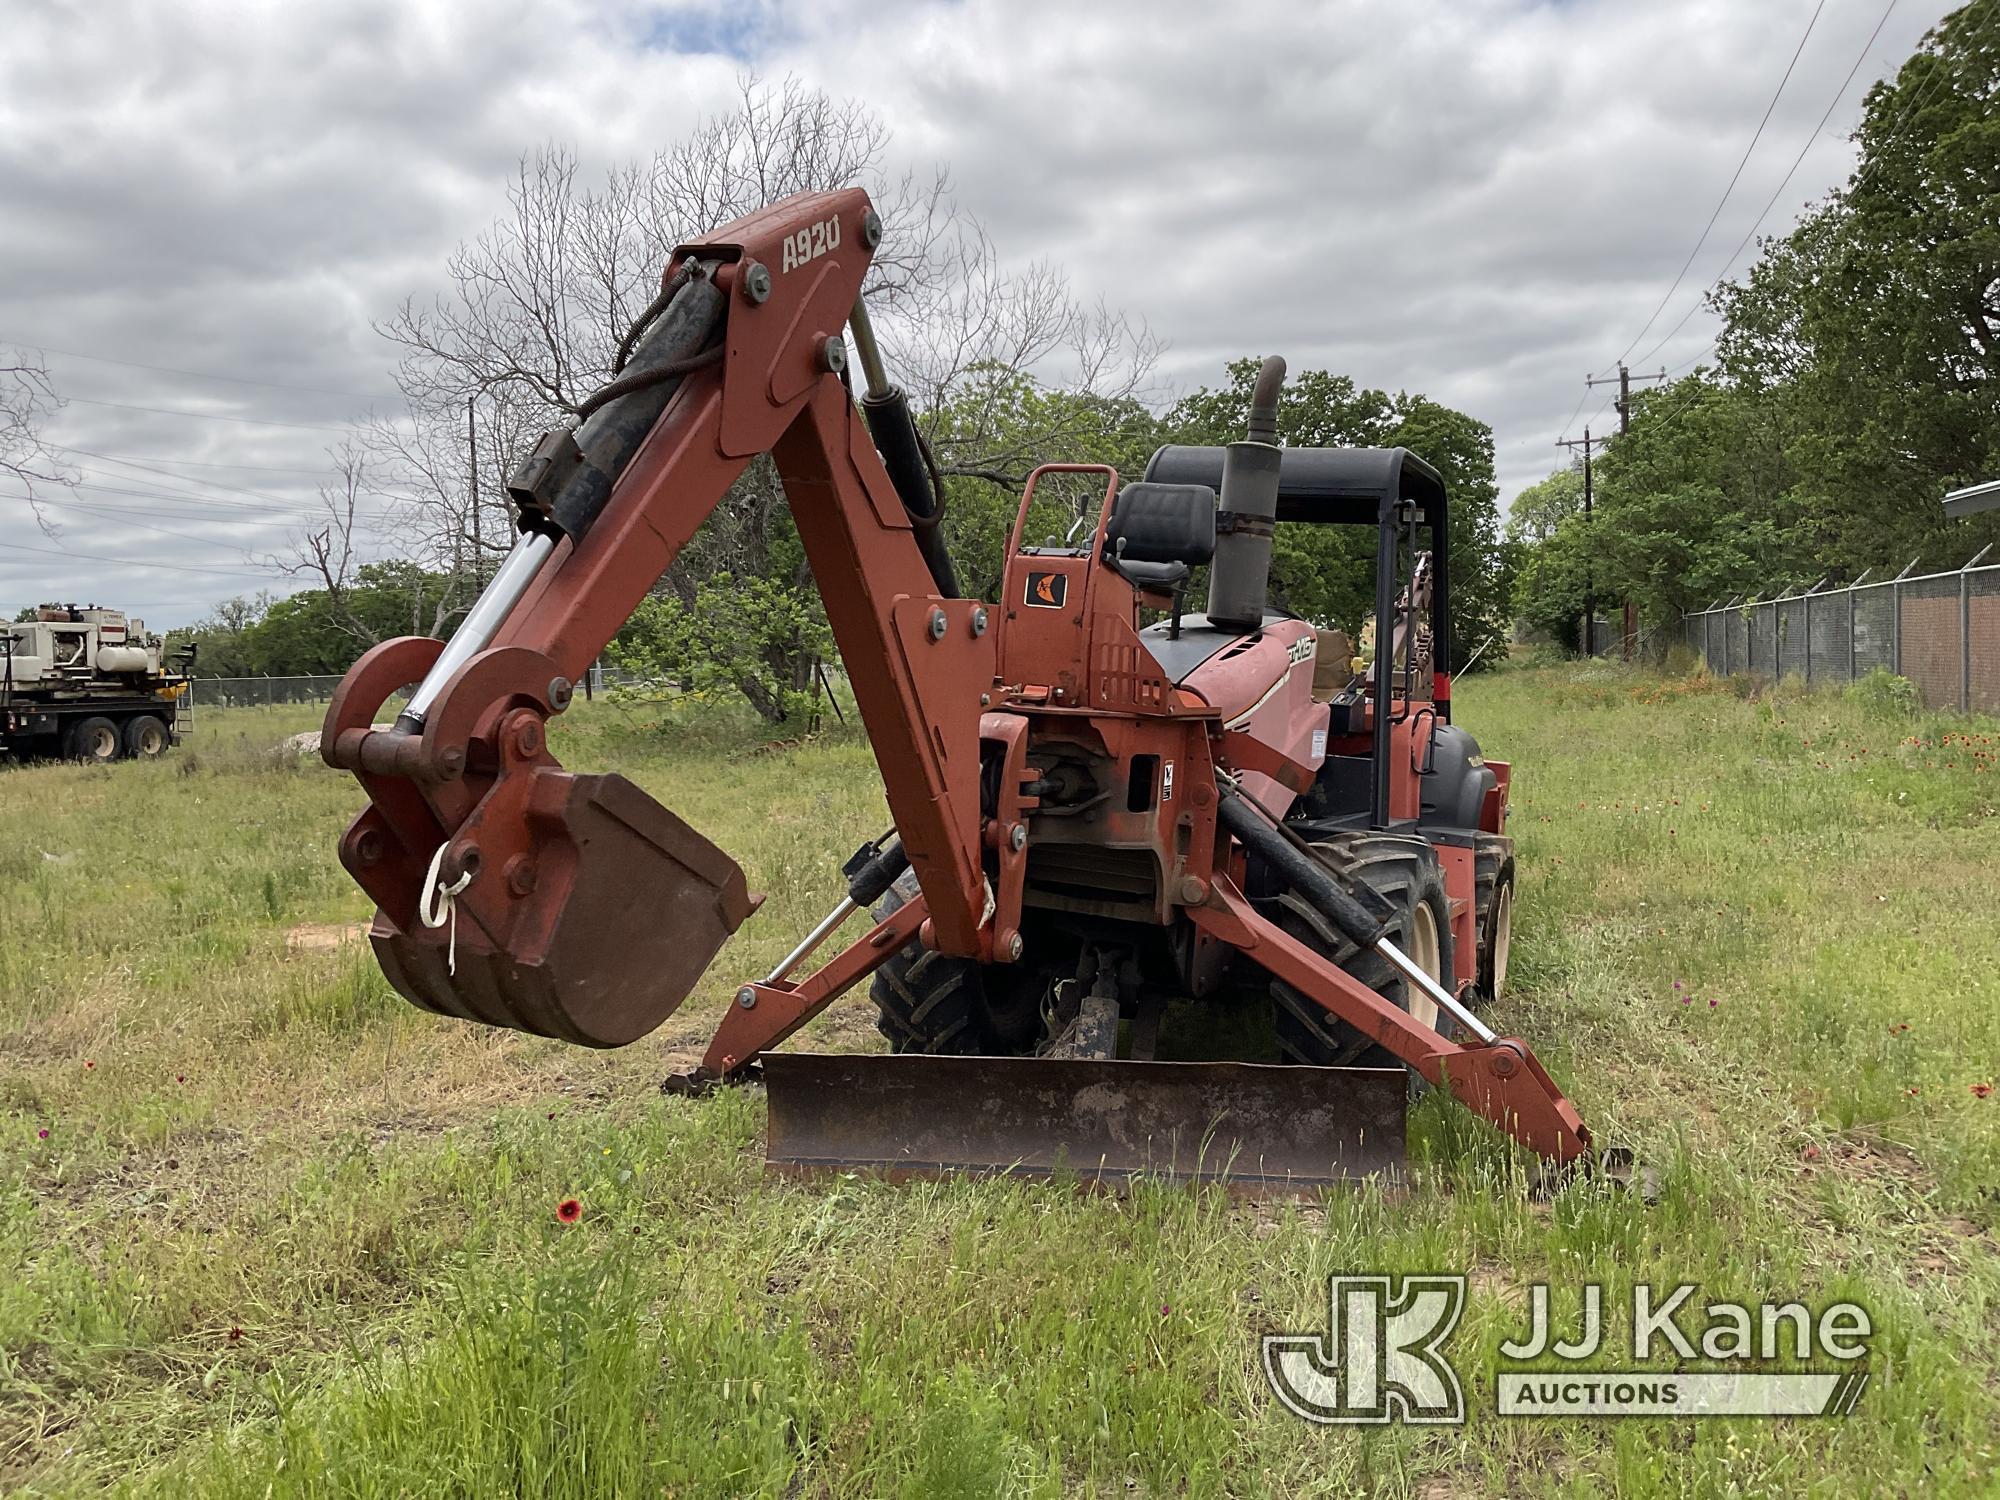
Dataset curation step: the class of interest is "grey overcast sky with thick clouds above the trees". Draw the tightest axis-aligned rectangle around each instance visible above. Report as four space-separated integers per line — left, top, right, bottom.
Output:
0 0 1952 626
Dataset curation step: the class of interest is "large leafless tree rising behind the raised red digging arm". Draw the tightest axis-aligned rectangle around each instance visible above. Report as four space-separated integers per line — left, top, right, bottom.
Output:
370 76 1158 714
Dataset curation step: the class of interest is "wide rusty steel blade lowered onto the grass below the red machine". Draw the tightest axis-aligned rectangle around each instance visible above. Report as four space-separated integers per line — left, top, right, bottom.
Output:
762 1052 1408 1196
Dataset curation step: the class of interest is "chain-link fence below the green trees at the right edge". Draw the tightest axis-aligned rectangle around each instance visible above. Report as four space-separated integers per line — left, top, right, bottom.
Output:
1682 554 2000 714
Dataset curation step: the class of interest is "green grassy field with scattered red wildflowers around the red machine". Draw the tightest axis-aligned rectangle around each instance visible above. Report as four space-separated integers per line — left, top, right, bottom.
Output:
0 666 2000 1500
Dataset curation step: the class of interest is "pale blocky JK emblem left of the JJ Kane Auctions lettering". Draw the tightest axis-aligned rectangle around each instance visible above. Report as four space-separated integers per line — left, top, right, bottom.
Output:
1264 1276 1466 1424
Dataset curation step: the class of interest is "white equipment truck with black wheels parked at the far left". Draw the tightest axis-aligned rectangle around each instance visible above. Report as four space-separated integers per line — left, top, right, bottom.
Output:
0 604 188 762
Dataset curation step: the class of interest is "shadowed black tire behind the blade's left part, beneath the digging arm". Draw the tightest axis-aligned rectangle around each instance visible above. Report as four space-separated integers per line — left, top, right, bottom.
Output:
868 870 1042 1056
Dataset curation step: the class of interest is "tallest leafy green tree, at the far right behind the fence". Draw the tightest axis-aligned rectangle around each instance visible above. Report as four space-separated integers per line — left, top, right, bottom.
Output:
1704 2 2000 576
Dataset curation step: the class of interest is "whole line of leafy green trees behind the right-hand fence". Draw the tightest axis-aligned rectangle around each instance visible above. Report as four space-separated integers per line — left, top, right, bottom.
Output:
1510 2 2000 638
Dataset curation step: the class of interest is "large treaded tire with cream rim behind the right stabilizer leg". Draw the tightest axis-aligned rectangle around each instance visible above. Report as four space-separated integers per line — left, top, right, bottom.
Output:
1270 834 1452 1068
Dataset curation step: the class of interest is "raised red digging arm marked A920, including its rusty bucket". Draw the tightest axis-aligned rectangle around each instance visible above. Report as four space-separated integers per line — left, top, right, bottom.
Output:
322 190 994 1046
